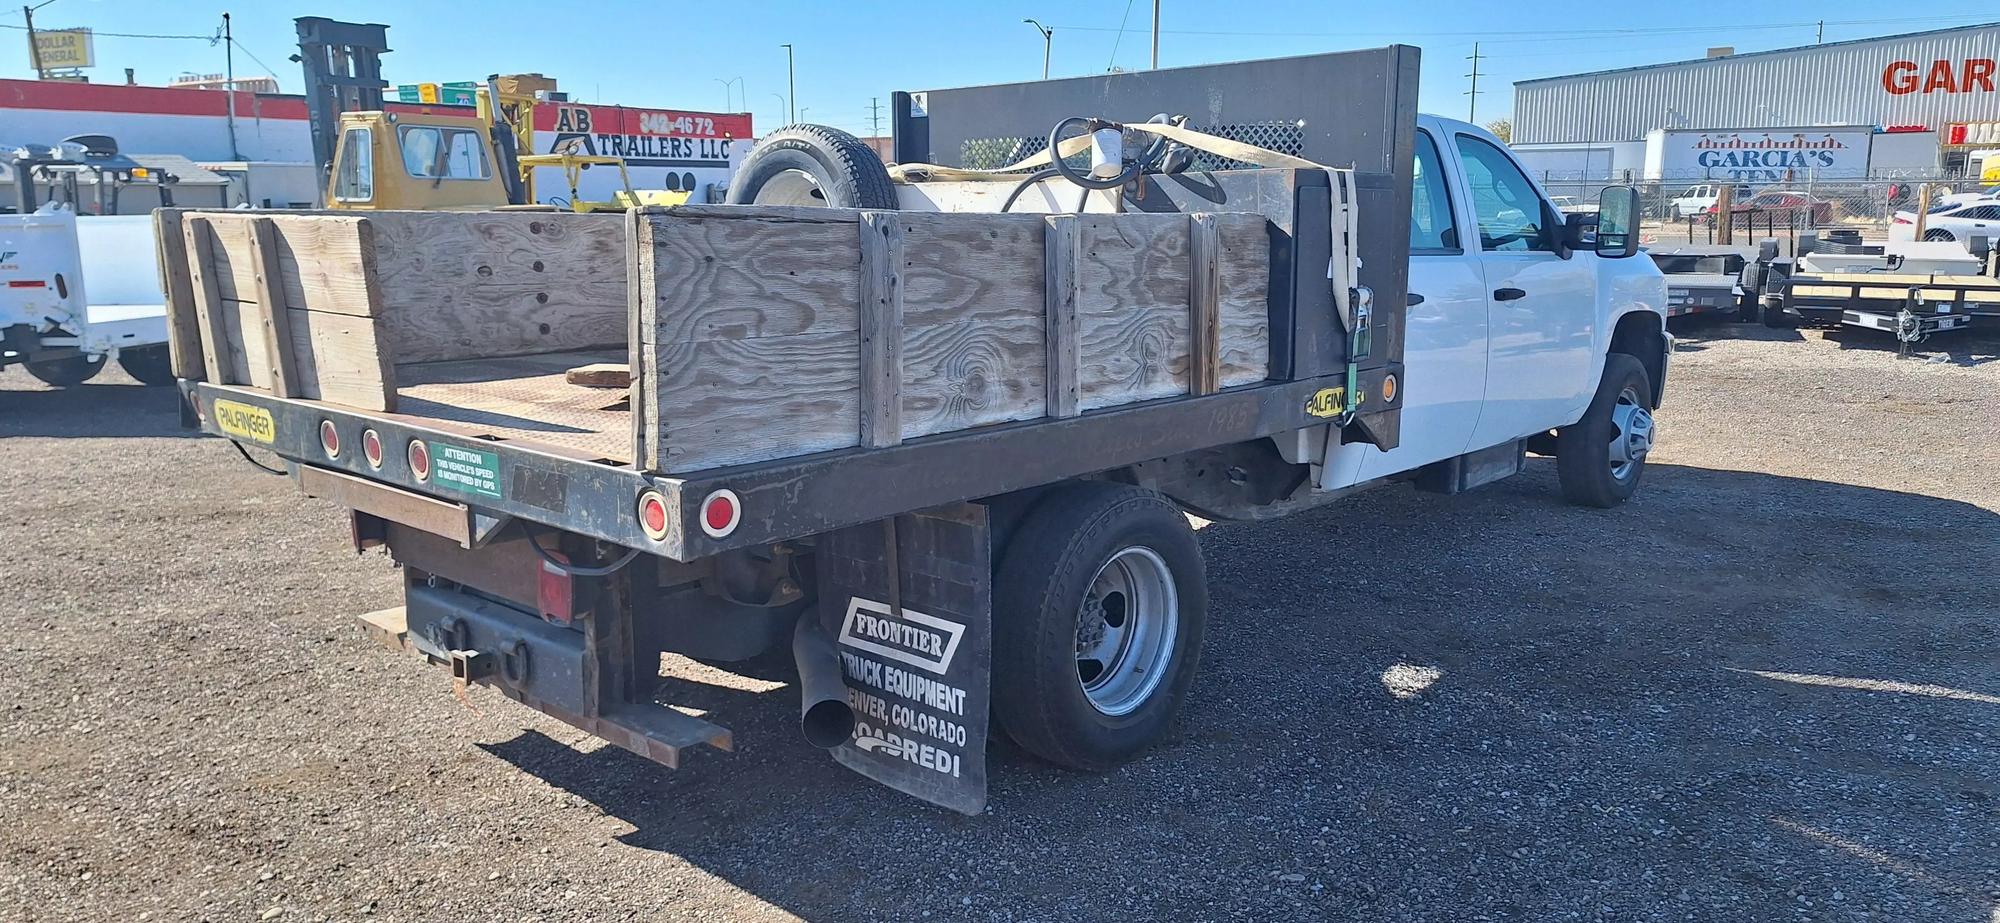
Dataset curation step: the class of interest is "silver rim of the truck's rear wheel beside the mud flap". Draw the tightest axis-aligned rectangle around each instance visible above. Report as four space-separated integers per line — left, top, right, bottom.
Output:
1076 545 1180 717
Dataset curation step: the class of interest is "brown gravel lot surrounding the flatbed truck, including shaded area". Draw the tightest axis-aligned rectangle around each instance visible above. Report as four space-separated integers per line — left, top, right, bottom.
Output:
0 326 2000 923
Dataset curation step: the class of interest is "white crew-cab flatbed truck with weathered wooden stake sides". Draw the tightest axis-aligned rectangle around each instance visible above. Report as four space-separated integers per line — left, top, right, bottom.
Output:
160 46 1670 813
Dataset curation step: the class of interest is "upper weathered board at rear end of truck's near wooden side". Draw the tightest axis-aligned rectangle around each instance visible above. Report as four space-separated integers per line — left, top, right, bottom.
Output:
646 208 860 344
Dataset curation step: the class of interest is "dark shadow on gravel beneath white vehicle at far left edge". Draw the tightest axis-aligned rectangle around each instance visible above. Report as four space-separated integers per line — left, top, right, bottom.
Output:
0 370 200 438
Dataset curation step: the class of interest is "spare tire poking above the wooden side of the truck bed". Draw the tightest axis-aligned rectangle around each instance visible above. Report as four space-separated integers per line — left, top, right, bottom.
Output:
728 124 896 208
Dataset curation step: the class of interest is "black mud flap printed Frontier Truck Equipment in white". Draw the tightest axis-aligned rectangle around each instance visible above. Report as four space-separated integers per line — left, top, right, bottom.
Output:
816 503 992 815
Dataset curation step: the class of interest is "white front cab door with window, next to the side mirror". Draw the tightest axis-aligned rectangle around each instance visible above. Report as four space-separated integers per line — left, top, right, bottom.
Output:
1452 130 1598 450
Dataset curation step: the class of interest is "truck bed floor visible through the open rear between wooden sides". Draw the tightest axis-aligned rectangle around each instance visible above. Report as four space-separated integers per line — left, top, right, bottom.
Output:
396 350 632 463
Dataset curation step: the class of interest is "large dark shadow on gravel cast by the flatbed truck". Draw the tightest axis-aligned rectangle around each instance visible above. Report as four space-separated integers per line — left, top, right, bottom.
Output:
486 465 2000 923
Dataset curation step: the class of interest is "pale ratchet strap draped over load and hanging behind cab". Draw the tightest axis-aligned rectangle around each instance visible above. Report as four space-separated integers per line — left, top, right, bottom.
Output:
888 122 1374 415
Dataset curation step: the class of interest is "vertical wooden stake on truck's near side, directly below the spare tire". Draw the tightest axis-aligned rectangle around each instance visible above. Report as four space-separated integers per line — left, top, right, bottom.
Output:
858 212 904 446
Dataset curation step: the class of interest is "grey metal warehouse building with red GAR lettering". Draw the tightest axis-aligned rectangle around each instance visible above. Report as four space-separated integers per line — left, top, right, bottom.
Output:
1514 22 2000 172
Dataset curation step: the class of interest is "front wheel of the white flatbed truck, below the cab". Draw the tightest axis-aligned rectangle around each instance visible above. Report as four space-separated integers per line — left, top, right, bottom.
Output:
1556 352 1654 509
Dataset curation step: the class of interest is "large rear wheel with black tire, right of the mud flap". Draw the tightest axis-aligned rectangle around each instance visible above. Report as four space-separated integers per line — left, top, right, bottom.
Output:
992 481 1208 771
